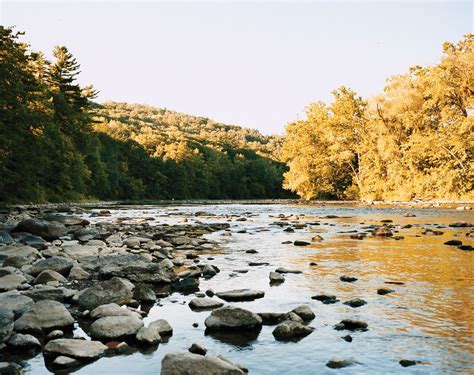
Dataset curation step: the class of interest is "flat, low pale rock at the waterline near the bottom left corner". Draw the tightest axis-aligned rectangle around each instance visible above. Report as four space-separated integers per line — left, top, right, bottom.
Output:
44 339 107 360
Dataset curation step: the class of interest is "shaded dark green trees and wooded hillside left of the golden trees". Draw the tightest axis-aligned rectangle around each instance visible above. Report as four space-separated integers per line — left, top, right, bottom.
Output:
0 26 289 202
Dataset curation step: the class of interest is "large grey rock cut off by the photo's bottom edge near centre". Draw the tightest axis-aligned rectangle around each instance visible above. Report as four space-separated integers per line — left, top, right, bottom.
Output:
161 353 247 375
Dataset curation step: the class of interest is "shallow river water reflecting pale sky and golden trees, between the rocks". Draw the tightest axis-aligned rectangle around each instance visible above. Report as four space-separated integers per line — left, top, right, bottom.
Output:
27 204 474 374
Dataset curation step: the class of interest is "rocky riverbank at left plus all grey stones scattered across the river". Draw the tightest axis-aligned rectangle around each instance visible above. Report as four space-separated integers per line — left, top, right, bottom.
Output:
0 207 473 374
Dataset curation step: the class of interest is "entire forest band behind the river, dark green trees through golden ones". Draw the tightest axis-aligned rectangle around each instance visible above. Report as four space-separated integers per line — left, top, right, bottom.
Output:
0 27 474 203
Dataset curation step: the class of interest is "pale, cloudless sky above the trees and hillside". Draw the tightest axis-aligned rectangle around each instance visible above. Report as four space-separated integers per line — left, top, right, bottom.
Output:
0 0 473 134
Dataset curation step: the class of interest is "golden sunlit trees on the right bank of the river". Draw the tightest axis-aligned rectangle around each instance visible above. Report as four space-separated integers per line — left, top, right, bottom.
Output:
282 34 474 200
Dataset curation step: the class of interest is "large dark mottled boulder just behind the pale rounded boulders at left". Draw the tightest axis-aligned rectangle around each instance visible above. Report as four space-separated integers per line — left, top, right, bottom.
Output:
77 277 133 310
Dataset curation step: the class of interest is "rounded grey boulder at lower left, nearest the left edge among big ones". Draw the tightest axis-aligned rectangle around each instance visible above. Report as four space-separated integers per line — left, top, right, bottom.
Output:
15 300 74 333
